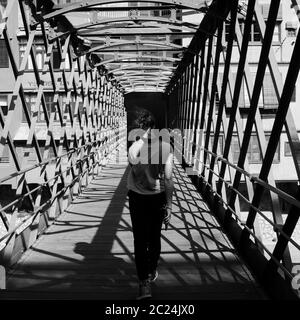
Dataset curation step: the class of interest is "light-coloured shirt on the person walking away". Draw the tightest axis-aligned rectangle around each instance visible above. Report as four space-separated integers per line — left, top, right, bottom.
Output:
127 139 172 194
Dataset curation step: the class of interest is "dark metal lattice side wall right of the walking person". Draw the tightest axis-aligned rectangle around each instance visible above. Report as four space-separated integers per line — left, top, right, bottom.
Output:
168 0 300 297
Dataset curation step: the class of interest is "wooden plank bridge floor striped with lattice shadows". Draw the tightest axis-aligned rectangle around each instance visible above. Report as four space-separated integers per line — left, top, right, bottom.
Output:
6 145 266 300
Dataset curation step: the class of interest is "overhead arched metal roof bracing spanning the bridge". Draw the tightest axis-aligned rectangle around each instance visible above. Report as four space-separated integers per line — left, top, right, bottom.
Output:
30 0 210 93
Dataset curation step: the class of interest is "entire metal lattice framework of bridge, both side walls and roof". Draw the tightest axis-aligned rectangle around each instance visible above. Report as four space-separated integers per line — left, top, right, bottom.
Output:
0 0 300 298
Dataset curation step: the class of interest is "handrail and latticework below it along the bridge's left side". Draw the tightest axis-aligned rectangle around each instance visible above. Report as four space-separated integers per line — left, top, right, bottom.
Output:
0 128 126 265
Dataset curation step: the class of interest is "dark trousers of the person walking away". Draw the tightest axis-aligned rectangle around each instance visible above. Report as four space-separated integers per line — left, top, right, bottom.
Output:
128 190 166 280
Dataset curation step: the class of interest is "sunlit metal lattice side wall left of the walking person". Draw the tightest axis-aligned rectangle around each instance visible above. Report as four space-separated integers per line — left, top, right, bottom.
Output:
0 0 126 264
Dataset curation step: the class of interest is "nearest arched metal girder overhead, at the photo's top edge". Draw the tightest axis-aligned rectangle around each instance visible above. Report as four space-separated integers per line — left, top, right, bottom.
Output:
38 0 207 20
